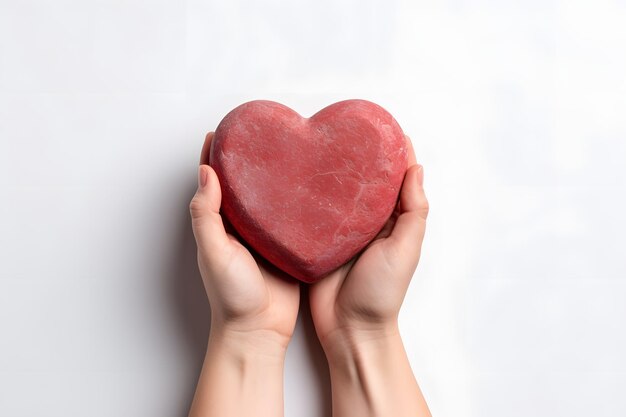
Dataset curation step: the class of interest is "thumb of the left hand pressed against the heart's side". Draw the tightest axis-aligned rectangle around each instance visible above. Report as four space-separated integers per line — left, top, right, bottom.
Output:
189 165 228 252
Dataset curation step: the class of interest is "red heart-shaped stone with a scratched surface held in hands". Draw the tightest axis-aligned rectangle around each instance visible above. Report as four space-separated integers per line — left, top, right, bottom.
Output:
210 100 407 282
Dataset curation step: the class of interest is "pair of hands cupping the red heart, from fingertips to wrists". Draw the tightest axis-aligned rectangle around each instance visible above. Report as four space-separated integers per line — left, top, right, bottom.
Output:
190 133 428 356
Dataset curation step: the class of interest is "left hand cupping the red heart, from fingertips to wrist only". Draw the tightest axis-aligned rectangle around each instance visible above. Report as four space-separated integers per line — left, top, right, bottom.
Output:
189 133 300 349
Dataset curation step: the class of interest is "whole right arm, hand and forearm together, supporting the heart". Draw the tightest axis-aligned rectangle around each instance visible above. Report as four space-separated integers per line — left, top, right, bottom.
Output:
309 137 430 417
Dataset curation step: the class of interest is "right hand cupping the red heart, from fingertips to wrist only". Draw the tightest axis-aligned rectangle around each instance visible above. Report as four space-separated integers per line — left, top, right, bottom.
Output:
309 136 428 355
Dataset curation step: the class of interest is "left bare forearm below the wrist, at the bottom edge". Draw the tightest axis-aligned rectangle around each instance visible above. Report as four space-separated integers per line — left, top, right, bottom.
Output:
189 331 285 417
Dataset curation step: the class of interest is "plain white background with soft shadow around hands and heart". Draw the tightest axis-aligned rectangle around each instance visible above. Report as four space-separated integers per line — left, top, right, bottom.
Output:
0 0 626 417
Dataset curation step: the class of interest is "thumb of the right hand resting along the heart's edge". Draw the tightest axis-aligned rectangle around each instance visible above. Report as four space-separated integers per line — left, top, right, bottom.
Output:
384 164 429 256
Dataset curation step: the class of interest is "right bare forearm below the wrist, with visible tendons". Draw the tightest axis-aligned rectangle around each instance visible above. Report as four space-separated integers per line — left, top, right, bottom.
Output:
325 328 430 417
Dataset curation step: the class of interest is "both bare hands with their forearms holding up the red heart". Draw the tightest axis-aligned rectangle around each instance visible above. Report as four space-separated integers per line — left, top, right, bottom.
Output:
189 133 430 417
